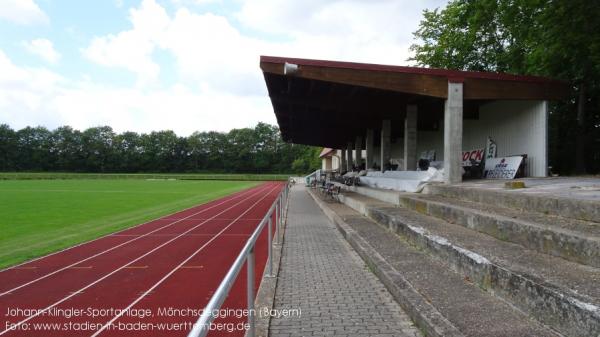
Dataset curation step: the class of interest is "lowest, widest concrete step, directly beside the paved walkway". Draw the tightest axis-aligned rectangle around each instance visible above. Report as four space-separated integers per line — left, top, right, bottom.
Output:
313 189 559 337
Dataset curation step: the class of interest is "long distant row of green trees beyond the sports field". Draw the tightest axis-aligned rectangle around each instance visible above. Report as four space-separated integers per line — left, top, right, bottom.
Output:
0 123 320 173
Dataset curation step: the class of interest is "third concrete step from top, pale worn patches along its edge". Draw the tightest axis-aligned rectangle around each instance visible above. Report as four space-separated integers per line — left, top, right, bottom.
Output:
340 192 600 336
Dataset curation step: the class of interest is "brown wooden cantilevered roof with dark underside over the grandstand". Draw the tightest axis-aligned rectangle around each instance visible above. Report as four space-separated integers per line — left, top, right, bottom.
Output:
260 56 568 148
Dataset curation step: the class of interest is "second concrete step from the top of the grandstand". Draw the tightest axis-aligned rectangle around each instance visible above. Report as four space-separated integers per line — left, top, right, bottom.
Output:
400 193 600 267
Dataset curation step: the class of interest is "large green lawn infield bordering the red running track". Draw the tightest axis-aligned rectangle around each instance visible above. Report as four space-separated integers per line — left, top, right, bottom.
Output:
0 179 258 268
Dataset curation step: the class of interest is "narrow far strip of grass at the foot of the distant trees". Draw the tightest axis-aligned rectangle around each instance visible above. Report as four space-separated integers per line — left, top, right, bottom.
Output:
0 172 290 181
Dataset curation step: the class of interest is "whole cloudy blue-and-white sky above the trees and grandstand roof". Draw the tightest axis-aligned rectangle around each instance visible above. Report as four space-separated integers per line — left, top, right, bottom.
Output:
0 0 446 136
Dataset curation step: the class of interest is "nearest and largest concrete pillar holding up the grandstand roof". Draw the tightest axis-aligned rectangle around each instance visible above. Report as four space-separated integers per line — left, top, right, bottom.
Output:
444 82 463 184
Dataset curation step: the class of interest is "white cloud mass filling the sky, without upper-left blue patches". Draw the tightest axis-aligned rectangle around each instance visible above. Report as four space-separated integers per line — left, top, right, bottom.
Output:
0 0 444 135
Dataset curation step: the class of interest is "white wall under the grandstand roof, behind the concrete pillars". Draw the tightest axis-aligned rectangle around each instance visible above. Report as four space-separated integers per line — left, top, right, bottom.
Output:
392 101 548 177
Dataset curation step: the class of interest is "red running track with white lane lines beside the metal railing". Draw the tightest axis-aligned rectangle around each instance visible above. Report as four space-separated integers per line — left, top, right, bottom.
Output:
0 183 283 336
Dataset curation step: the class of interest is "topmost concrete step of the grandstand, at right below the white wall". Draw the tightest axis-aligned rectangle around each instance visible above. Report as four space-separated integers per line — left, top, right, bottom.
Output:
424 184 600 225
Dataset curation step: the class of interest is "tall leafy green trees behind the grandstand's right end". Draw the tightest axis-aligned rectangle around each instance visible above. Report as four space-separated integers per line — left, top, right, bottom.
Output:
411 0 600 173
